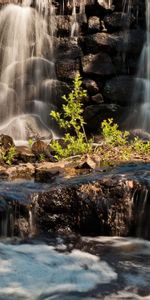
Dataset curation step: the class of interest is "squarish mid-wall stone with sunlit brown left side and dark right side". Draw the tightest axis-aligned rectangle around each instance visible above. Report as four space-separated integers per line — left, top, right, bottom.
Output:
82 52 114 76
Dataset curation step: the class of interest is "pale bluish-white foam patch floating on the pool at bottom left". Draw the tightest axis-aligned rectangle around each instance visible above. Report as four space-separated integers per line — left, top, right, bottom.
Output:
0 243 117 300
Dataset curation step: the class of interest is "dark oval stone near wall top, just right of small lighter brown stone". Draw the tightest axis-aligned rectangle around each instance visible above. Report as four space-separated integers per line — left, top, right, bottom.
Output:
104 12 134 32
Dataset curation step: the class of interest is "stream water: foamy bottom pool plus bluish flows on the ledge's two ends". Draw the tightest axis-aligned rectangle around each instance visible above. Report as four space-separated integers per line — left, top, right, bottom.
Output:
0 164 150 300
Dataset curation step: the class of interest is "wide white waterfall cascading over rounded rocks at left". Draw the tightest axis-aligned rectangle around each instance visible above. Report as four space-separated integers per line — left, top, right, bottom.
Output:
0 0 55 140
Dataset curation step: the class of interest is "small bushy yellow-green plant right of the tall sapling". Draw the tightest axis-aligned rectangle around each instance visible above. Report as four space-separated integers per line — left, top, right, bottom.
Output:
101 118 129 146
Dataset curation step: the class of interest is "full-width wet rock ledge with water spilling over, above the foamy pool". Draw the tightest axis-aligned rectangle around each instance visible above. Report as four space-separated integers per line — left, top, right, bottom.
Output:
0 164 150 239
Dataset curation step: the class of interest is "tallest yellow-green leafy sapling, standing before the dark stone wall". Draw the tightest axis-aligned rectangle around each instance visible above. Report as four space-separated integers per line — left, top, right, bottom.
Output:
50 73 92 158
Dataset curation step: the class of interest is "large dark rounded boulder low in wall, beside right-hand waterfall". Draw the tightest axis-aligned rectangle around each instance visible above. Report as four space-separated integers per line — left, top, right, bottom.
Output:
103 76 144 106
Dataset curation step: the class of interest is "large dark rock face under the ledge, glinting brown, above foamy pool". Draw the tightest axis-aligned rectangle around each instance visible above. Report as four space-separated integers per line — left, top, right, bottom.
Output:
32 177 132 236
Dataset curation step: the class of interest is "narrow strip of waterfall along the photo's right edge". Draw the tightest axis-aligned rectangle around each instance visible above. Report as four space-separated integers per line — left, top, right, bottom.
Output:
130 0 150 132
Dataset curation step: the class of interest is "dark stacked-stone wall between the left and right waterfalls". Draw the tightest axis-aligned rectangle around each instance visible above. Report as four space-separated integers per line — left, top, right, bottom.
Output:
54 0 145 131
